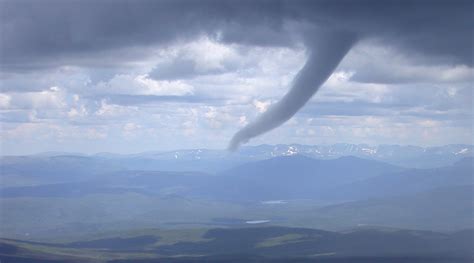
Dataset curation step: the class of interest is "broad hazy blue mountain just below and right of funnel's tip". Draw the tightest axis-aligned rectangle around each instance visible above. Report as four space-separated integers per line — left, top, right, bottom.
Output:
203 155 403 200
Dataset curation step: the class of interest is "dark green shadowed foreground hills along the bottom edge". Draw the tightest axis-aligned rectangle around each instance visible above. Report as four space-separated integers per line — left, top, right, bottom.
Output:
0 227 473 262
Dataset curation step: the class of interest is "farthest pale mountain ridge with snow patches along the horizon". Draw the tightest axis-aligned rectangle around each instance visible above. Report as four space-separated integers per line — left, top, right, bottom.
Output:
90 143 474 168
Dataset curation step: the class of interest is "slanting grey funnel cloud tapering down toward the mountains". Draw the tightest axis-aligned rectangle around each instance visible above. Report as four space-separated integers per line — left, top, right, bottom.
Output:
228 32 356 151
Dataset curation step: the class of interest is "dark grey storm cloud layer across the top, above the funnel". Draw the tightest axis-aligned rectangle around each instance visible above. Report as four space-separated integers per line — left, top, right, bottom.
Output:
0 0 473 70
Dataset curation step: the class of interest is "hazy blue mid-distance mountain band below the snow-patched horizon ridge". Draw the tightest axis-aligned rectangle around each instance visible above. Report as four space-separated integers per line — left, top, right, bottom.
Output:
0 154 474 201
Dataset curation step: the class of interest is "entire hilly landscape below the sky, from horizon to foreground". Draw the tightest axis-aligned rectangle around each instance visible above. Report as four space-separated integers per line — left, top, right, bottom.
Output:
0 145 474 262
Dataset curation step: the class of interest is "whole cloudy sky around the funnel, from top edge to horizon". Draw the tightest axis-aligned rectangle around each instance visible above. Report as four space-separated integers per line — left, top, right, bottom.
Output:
0 0 474 154
